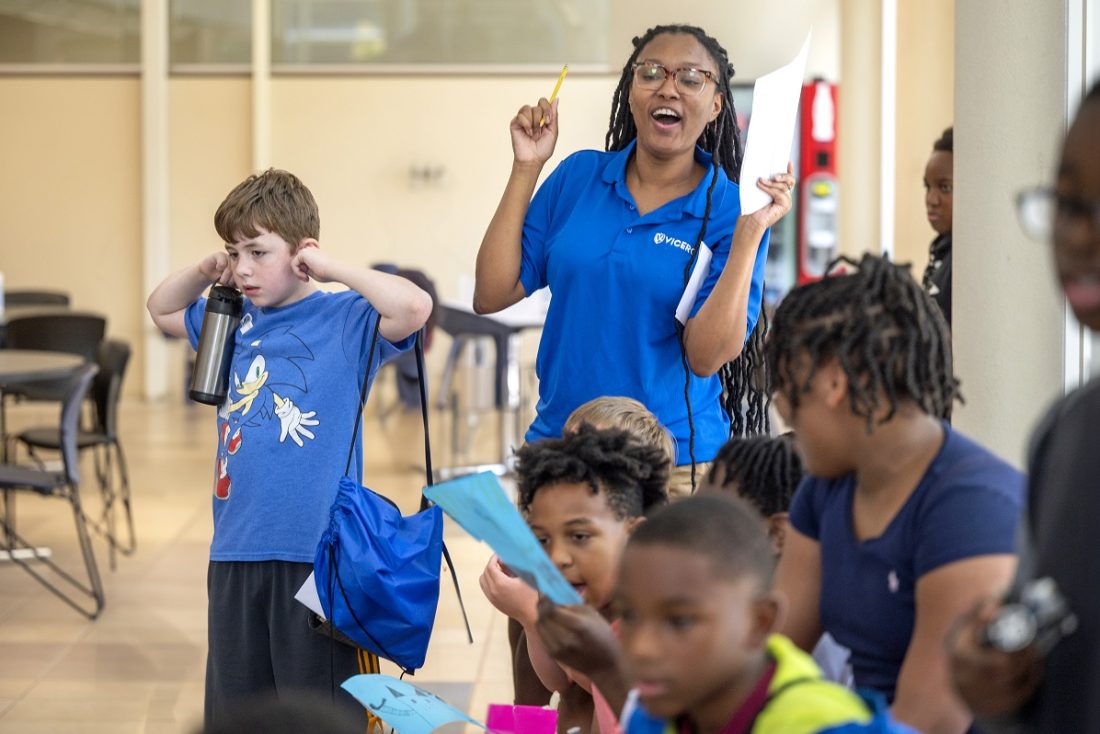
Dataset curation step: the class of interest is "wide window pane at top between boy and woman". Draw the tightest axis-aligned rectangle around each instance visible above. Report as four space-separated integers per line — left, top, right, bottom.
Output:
272 0 609 65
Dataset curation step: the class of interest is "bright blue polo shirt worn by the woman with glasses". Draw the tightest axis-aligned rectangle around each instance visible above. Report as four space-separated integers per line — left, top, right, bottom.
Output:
519 142 770 464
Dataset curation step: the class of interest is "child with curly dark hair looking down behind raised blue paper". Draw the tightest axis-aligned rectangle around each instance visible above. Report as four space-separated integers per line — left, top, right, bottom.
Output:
481 425 669 731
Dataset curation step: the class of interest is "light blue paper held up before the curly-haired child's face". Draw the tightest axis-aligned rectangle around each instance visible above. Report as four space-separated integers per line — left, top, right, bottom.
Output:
424 471 583 604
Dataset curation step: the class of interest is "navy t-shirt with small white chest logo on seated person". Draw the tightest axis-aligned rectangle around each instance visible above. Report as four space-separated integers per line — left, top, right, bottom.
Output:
791 424 1024 701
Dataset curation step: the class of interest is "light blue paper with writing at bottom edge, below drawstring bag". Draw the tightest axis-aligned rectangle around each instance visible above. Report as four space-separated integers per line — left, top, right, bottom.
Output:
340 675 488 734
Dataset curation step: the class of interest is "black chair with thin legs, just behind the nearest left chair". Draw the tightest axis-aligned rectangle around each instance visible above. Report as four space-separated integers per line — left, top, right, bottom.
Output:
15 339 136 571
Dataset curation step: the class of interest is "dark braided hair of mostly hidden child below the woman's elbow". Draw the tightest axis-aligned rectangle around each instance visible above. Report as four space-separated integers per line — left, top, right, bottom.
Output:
706 434 803 517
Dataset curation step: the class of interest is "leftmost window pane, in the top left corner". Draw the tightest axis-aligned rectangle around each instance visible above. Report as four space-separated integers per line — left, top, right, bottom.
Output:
0 0 141 64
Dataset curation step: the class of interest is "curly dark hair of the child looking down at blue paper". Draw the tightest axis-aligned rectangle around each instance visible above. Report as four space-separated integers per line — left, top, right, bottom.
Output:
516 424 669 519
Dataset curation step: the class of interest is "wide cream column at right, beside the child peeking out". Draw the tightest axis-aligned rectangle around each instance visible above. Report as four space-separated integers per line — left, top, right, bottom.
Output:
953 0 1078 465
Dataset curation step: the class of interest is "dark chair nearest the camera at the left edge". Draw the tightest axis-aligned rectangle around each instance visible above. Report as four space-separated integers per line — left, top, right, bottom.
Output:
0 364 103 620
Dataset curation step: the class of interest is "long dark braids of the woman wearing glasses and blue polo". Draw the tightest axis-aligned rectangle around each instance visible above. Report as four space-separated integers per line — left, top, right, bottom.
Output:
605 25 770 490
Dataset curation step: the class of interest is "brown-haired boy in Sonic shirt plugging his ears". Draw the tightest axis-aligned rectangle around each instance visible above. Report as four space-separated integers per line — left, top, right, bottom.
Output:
147 169 431 727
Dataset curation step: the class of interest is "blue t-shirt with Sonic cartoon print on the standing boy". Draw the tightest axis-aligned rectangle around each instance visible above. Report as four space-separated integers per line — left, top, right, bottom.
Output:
186 291 415 563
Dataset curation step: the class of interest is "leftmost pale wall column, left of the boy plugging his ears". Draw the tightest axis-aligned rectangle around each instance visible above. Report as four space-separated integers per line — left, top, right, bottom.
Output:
141 0 171 398
